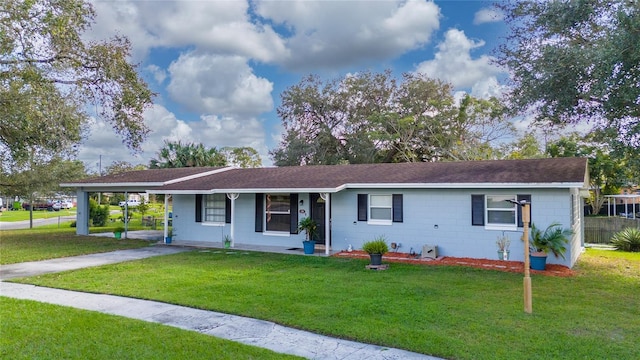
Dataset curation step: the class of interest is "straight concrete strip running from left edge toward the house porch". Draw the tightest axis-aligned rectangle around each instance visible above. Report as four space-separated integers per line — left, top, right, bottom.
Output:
0 245 193 280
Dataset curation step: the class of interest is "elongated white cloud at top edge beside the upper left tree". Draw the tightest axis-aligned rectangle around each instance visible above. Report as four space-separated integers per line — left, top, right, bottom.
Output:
92 0 287 62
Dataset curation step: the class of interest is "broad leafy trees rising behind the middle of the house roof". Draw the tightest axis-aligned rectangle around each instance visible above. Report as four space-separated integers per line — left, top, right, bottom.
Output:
270 71 508 166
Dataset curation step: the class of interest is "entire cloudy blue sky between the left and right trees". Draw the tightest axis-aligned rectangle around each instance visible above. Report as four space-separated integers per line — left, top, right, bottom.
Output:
79 0 506 171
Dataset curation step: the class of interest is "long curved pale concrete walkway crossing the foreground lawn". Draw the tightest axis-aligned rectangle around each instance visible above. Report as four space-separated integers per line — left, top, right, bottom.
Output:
0 282 438 360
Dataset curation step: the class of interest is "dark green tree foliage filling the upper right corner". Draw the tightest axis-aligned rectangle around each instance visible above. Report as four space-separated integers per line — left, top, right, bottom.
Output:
496 0 640 152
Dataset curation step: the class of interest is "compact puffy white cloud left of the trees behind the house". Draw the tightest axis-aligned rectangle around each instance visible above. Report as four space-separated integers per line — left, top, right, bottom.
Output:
167 53 273 116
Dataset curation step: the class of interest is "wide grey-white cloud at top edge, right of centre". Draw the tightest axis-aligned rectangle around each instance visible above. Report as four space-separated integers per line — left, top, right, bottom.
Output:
256 0 440 69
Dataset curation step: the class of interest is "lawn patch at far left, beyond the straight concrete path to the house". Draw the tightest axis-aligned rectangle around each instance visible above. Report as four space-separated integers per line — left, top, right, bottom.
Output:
0 225 150 264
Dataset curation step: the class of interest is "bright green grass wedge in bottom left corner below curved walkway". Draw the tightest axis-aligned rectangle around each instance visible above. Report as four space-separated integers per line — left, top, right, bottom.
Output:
0 297 297 360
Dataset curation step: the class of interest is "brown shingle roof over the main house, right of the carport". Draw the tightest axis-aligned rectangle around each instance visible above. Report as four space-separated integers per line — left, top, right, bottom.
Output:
152 158 587 192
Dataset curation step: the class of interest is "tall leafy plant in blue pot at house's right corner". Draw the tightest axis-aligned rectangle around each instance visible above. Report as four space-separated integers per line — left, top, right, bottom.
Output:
529 222 573 270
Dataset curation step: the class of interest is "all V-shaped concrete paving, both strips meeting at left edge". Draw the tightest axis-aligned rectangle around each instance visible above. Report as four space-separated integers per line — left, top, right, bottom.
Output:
0 246 438 360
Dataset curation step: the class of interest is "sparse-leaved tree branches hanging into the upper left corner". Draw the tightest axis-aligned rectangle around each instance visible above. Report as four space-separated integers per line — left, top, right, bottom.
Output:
0 0 153 165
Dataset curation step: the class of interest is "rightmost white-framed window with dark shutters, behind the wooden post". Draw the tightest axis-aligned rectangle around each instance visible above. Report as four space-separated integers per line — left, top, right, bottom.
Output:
471 195 531 229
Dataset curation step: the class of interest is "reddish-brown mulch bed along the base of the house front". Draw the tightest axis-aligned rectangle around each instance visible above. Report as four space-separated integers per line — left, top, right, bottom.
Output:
333 250 576 277
